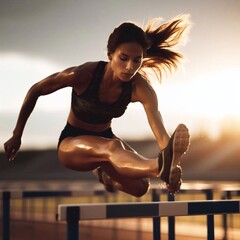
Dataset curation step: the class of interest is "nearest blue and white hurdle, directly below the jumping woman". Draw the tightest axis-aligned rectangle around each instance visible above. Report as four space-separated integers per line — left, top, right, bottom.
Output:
58 200 240 240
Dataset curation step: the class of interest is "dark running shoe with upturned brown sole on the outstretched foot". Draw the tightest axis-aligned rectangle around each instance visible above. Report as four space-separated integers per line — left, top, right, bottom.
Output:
158 124 190 194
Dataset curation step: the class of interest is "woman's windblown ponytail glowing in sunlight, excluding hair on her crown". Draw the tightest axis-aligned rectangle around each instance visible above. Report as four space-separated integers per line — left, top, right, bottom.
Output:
140 15 190 80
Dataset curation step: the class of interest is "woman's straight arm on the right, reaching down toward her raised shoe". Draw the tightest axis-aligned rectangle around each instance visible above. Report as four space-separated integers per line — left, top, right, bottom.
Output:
134 78 170 149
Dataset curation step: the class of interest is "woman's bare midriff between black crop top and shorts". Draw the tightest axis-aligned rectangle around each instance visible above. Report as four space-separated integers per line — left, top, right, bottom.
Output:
68 110 111 132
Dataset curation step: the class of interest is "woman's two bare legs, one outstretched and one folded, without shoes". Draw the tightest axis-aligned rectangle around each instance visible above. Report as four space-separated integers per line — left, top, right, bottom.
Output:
59 136 152 197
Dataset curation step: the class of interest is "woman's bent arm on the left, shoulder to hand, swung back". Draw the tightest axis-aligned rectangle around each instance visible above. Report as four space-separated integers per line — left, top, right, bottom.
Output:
4 67 77 160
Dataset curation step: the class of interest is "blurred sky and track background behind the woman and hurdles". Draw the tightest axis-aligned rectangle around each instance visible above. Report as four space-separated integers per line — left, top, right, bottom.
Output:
0 0 240 240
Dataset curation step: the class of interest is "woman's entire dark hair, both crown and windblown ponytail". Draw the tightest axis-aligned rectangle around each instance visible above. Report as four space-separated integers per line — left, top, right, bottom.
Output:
107 14 190 81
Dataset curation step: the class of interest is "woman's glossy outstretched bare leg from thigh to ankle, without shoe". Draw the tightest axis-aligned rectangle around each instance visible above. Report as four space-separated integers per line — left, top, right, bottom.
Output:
58 136 159 179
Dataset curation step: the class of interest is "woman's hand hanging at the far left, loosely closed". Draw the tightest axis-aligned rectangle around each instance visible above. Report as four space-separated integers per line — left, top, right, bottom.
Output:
4 135 21 161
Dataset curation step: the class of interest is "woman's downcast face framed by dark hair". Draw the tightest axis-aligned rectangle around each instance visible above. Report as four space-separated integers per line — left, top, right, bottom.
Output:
109 42 143 82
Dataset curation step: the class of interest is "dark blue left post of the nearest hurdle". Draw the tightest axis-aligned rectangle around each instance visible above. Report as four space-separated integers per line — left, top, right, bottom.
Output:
67 207 79 240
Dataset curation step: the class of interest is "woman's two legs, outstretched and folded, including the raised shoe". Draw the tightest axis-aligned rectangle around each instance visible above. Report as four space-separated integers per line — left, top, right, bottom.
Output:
59 124 190 196
